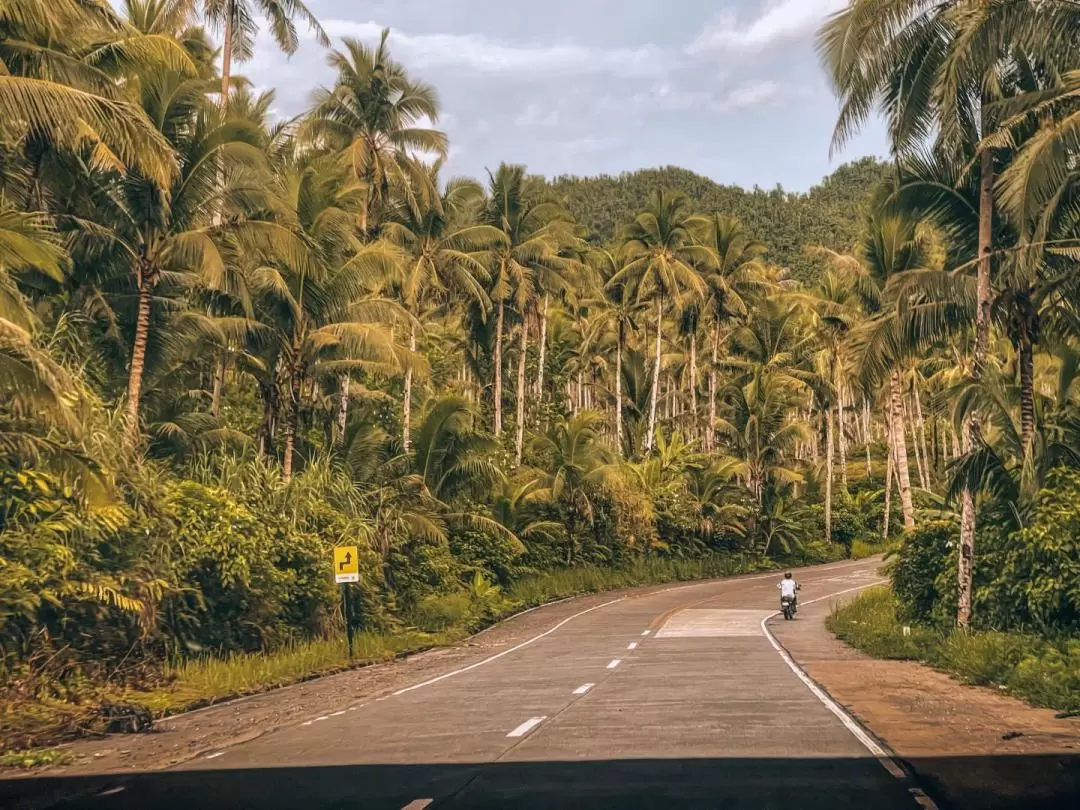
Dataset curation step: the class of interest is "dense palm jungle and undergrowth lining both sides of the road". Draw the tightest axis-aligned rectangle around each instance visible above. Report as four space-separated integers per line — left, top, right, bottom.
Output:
6 0 1080 743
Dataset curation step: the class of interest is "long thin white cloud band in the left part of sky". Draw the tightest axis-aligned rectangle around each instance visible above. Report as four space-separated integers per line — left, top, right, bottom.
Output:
323 19 671 77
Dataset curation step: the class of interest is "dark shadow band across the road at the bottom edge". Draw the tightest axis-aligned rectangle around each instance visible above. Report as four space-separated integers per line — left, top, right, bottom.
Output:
0 756 1080 810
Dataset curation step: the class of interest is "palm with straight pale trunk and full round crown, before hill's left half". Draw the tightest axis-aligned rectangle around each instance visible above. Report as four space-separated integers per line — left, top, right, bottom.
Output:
608 191 717 454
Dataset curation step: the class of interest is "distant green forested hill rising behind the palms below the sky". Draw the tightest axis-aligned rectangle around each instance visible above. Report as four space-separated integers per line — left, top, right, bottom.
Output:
552 158 888 280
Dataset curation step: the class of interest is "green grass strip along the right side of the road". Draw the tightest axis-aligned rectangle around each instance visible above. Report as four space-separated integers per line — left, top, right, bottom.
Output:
826 588 1080 714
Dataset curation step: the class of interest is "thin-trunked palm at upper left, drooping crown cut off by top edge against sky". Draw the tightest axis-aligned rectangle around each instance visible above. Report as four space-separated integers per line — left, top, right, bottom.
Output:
199 0 330 107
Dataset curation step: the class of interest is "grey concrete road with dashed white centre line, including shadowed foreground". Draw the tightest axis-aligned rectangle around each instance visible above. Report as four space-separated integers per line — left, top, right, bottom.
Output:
6 561 930 810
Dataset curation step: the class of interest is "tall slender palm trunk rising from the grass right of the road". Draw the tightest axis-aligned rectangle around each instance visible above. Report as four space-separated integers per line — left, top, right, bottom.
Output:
956 144 994 629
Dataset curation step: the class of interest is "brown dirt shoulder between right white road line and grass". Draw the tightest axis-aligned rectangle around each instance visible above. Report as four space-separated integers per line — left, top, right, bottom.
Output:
773 597 1080 808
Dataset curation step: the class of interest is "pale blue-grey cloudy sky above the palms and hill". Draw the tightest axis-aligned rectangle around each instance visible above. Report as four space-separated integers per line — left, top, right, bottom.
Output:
239 0 887 191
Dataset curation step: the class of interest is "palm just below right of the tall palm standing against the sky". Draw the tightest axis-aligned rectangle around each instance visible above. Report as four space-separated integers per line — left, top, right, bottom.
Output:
382 164 505 453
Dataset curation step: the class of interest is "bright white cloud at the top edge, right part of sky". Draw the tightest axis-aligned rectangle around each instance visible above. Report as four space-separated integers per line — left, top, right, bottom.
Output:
687 0 848 54
